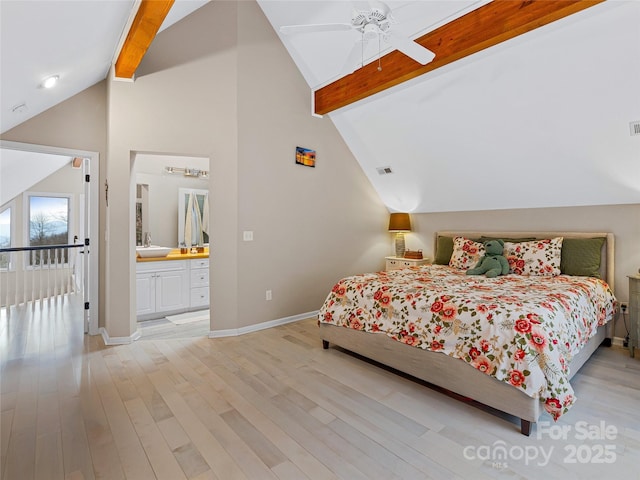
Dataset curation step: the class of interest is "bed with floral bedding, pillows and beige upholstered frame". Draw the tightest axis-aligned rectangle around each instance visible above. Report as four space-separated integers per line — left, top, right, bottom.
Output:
318 231 617 436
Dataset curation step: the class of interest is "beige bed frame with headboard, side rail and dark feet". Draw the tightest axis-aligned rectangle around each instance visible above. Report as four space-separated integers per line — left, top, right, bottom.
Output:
320 231 614 436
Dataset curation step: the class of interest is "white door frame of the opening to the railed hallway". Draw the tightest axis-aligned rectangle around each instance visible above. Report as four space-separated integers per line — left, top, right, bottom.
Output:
0 140 100 335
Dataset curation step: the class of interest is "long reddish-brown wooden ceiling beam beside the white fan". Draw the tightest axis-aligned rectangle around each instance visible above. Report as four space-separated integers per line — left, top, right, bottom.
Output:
314 0 604 115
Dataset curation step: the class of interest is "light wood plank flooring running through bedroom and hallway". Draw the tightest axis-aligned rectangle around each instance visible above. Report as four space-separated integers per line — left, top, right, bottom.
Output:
0 302 640 480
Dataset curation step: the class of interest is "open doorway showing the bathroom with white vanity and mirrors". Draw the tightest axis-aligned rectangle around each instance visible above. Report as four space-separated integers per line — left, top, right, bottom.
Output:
131 152 211 339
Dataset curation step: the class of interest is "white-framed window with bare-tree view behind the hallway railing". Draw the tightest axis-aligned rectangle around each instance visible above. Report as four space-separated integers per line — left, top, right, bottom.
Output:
28 194 71 265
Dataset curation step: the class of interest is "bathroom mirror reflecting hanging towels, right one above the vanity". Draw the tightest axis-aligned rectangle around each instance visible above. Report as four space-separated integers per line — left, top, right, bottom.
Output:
178 188 210 247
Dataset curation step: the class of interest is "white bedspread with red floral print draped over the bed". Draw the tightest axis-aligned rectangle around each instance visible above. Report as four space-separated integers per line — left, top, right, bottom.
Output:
319 265 616 420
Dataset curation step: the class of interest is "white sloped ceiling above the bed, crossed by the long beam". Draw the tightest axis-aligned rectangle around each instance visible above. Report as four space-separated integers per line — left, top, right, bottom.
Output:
259 0 640 212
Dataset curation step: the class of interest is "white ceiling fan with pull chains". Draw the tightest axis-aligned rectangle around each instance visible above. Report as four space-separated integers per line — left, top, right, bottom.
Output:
280 1 435 75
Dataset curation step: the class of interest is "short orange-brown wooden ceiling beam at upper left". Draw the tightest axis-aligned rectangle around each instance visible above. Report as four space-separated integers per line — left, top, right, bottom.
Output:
115 0 175 78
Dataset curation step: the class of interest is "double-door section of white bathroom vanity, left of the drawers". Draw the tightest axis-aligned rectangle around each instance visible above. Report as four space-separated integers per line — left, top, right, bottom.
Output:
136 260 189 316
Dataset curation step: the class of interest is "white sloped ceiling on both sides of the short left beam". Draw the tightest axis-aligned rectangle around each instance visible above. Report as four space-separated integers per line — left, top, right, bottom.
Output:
0 0 208 132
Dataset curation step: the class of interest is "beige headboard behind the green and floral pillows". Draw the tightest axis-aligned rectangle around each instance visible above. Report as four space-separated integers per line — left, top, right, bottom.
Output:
434 231 615 290
